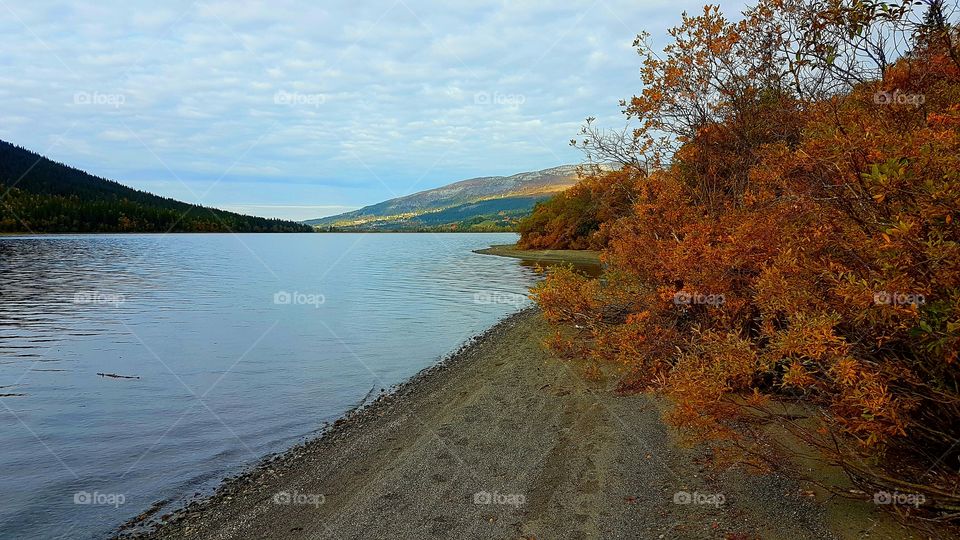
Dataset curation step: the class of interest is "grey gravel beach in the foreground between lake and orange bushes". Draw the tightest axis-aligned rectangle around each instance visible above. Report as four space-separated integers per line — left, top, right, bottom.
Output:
120 307 931 540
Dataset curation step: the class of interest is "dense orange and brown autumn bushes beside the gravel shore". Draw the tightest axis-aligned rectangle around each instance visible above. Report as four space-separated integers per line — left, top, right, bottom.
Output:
523 0 960 518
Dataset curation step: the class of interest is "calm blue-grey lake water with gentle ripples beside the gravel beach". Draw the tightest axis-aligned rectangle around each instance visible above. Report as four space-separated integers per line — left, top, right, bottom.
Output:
0 234 537 538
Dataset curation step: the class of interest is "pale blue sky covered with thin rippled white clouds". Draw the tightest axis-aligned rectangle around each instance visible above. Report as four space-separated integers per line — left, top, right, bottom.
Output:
0 0 742 220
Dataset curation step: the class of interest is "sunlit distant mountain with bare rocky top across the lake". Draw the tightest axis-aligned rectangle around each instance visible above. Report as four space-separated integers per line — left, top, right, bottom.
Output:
305 165 577 230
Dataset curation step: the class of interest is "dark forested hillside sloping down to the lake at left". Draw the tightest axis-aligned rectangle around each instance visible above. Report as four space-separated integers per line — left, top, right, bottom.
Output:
0 141 313 232
